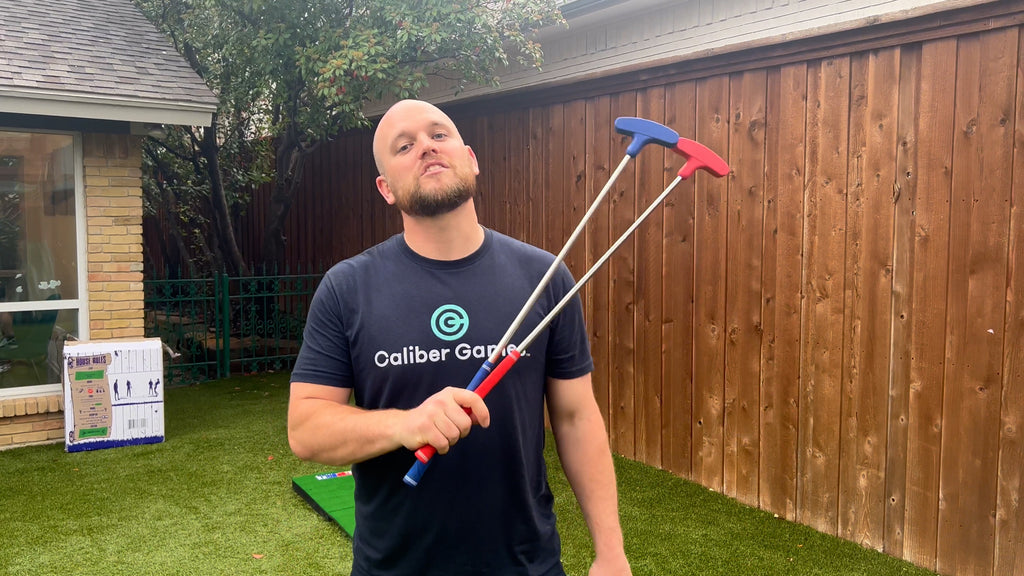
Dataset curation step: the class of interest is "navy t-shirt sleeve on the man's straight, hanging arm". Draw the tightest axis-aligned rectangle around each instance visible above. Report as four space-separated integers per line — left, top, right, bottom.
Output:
546 263 594 380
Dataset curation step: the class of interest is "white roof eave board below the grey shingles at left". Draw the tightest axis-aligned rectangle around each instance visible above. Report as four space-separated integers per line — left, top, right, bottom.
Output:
0 88 217 126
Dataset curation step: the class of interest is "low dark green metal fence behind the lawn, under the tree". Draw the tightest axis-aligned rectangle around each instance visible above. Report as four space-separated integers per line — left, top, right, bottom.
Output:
143 274 323 385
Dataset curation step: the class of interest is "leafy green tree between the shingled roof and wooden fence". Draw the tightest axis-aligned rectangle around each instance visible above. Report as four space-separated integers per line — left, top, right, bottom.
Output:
135 0 563 274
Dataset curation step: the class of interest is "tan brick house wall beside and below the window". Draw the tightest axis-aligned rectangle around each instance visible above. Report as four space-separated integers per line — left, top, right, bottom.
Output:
0 134 145 450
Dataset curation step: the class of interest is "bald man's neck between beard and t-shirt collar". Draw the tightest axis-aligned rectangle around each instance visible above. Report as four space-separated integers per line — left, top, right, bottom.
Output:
401 199 483 260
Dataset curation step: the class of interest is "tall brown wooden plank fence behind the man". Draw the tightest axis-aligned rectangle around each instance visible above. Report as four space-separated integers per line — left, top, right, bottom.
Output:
232 2 1024 576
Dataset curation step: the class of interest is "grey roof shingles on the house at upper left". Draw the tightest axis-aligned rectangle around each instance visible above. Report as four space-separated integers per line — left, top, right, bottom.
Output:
0 0 217 106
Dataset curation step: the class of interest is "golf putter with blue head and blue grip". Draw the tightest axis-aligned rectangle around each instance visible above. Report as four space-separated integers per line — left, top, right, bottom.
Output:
403 117 679 486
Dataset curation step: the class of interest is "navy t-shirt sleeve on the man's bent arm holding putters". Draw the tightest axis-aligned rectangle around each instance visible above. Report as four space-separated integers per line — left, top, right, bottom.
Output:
292 273 353 388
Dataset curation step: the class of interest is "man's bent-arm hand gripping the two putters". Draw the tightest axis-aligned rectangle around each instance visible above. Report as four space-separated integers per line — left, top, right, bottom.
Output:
398 386 490 454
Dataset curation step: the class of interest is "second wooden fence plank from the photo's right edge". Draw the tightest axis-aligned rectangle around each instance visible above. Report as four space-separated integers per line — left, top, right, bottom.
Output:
938 28 1018 574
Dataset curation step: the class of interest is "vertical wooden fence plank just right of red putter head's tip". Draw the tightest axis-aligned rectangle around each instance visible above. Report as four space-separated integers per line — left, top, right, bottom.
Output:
724 70 768 504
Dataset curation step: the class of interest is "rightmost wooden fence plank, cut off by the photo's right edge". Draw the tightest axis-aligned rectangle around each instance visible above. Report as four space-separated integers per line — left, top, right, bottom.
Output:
993 30 1024 576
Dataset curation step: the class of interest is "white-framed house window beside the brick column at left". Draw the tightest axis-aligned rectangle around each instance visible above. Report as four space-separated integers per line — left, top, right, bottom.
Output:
0 130 87 398
